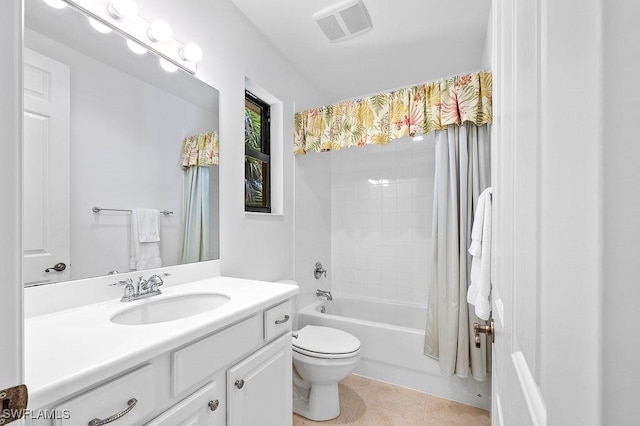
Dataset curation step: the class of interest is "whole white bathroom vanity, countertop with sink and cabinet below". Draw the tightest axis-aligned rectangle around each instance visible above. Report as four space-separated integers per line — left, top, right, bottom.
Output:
25 276 298 426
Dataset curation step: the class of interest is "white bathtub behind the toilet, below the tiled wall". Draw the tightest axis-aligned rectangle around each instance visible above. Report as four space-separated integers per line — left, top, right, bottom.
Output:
298 297 491 410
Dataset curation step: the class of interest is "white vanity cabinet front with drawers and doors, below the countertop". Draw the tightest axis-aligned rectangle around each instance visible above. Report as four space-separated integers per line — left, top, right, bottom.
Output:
26 292 293 426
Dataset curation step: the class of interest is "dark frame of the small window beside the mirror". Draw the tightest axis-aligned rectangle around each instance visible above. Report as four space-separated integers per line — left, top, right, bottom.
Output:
244 90 271 213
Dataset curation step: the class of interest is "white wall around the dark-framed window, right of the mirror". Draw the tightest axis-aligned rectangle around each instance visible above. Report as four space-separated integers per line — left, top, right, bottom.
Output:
132 0 324 280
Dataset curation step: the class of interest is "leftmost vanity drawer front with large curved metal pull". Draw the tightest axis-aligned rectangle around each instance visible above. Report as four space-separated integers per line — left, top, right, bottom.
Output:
54 365 159 426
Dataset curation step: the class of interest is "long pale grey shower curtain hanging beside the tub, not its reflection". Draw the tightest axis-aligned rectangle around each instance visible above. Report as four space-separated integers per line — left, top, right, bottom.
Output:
424 122 491 380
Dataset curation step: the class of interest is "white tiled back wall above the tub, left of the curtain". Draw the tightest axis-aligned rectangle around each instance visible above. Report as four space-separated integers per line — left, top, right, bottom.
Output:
331 134 435 305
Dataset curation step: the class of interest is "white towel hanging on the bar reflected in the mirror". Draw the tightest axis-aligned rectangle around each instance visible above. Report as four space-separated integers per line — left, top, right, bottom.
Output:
129 209 162 270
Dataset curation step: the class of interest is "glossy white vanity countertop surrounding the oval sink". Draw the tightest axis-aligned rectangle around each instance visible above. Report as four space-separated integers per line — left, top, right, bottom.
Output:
24 277 298 409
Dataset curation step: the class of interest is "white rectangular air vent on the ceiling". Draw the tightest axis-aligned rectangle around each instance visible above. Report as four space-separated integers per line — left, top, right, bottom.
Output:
313 0 372 41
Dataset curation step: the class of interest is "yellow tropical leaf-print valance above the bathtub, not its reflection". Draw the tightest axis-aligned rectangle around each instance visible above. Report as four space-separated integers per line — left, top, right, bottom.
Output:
293 71 492 154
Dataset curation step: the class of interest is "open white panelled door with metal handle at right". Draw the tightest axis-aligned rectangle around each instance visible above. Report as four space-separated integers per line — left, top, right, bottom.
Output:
491 0 546 426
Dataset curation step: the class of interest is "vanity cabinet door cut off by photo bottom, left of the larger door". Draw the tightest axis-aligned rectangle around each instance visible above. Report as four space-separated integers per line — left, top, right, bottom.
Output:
146 381 225 426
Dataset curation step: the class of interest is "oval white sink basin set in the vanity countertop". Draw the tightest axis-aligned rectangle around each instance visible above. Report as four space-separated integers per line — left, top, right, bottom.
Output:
111 293 230 325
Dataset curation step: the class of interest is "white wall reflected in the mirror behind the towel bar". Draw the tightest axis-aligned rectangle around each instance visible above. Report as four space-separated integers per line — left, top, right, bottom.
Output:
25 29 218 279
